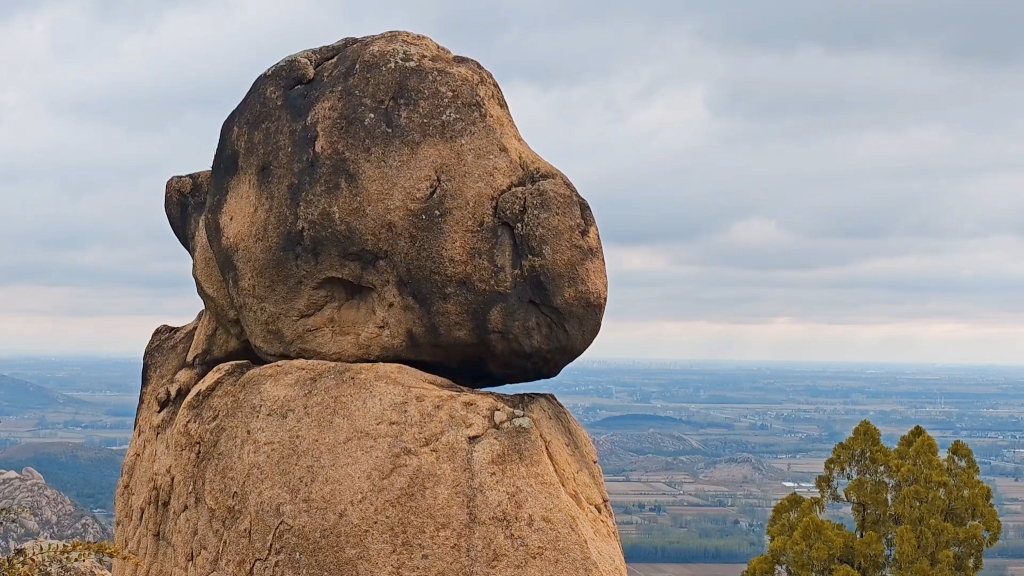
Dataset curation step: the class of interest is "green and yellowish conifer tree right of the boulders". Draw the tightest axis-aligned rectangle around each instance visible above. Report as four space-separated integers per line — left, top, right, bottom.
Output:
744 420 1002 576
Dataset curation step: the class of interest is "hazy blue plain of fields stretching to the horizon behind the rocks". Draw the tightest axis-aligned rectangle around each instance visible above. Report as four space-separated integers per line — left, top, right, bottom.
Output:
6 358 1024 565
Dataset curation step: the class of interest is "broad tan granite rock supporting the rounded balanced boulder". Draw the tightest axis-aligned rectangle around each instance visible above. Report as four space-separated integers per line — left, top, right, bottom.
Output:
114 323 626 576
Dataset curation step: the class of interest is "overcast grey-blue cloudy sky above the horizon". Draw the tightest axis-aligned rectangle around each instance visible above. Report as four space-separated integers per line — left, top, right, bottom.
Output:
0 0 1024 364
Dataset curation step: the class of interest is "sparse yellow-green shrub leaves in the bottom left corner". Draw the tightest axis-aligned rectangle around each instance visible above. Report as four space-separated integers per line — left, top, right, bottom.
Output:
0 508 133 576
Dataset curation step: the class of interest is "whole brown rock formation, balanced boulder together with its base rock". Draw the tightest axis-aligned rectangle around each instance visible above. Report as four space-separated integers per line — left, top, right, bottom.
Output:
115 32 626 576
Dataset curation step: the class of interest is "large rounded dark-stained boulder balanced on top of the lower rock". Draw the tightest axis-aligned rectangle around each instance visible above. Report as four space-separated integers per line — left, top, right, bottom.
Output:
166 32 607 387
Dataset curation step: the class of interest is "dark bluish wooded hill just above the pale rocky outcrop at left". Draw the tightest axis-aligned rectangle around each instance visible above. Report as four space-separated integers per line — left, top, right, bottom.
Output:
0 442 125 510
